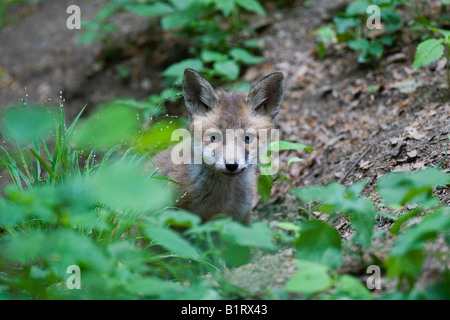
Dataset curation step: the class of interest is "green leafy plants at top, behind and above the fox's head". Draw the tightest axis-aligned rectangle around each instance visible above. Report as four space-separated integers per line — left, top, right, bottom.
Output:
80 0 266 84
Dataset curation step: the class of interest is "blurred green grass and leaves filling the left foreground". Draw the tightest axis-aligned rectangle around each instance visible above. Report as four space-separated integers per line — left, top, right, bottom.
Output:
0 100 284 299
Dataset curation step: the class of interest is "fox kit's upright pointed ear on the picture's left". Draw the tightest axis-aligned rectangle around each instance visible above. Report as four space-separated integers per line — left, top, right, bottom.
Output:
183 69 220 115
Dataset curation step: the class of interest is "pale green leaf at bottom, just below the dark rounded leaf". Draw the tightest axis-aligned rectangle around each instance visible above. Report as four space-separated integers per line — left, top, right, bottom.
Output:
284 260 333 294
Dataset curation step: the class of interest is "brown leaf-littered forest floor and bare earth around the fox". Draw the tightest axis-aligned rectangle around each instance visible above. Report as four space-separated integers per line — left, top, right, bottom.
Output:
0 0 450 297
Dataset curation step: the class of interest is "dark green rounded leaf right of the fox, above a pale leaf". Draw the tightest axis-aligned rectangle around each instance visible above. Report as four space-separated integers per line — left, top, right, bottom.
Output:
294 220 342 268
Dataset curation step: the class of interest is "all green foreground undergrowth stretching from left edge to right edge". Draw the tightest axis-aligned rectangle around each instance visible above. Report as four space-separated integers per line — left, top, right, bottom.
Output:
0 95 450 299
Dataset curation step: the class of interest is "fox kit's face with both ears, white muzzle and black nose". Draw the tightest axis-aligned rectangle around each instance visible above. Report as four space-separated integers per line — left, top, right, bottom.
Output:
183 69 284 177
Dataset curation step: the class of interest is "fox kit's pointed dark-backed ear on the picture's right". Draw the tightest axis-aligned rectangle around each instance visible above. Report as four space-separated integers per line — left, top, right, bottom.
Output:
247 72 284 118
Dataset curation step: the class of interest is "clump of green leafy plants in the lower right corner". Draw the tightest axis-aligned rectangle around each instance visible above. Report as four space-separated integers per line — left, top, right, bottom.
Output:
288 168 450 299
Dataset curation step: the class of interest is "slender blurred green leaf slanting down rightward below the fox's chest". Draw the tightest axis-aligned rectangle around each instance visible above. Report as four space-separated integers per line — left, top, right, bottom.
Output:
144 227 202 261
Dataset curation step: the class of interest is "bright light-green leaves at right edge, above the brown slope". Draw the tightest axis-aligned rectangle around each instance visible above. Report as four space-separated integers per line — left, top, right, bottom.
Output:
413 28 450 89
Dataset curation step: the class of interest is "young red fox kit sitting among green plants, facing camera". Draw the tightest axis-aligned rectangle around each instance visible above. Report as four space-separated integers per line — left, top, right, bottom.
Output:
153 69 284 222
